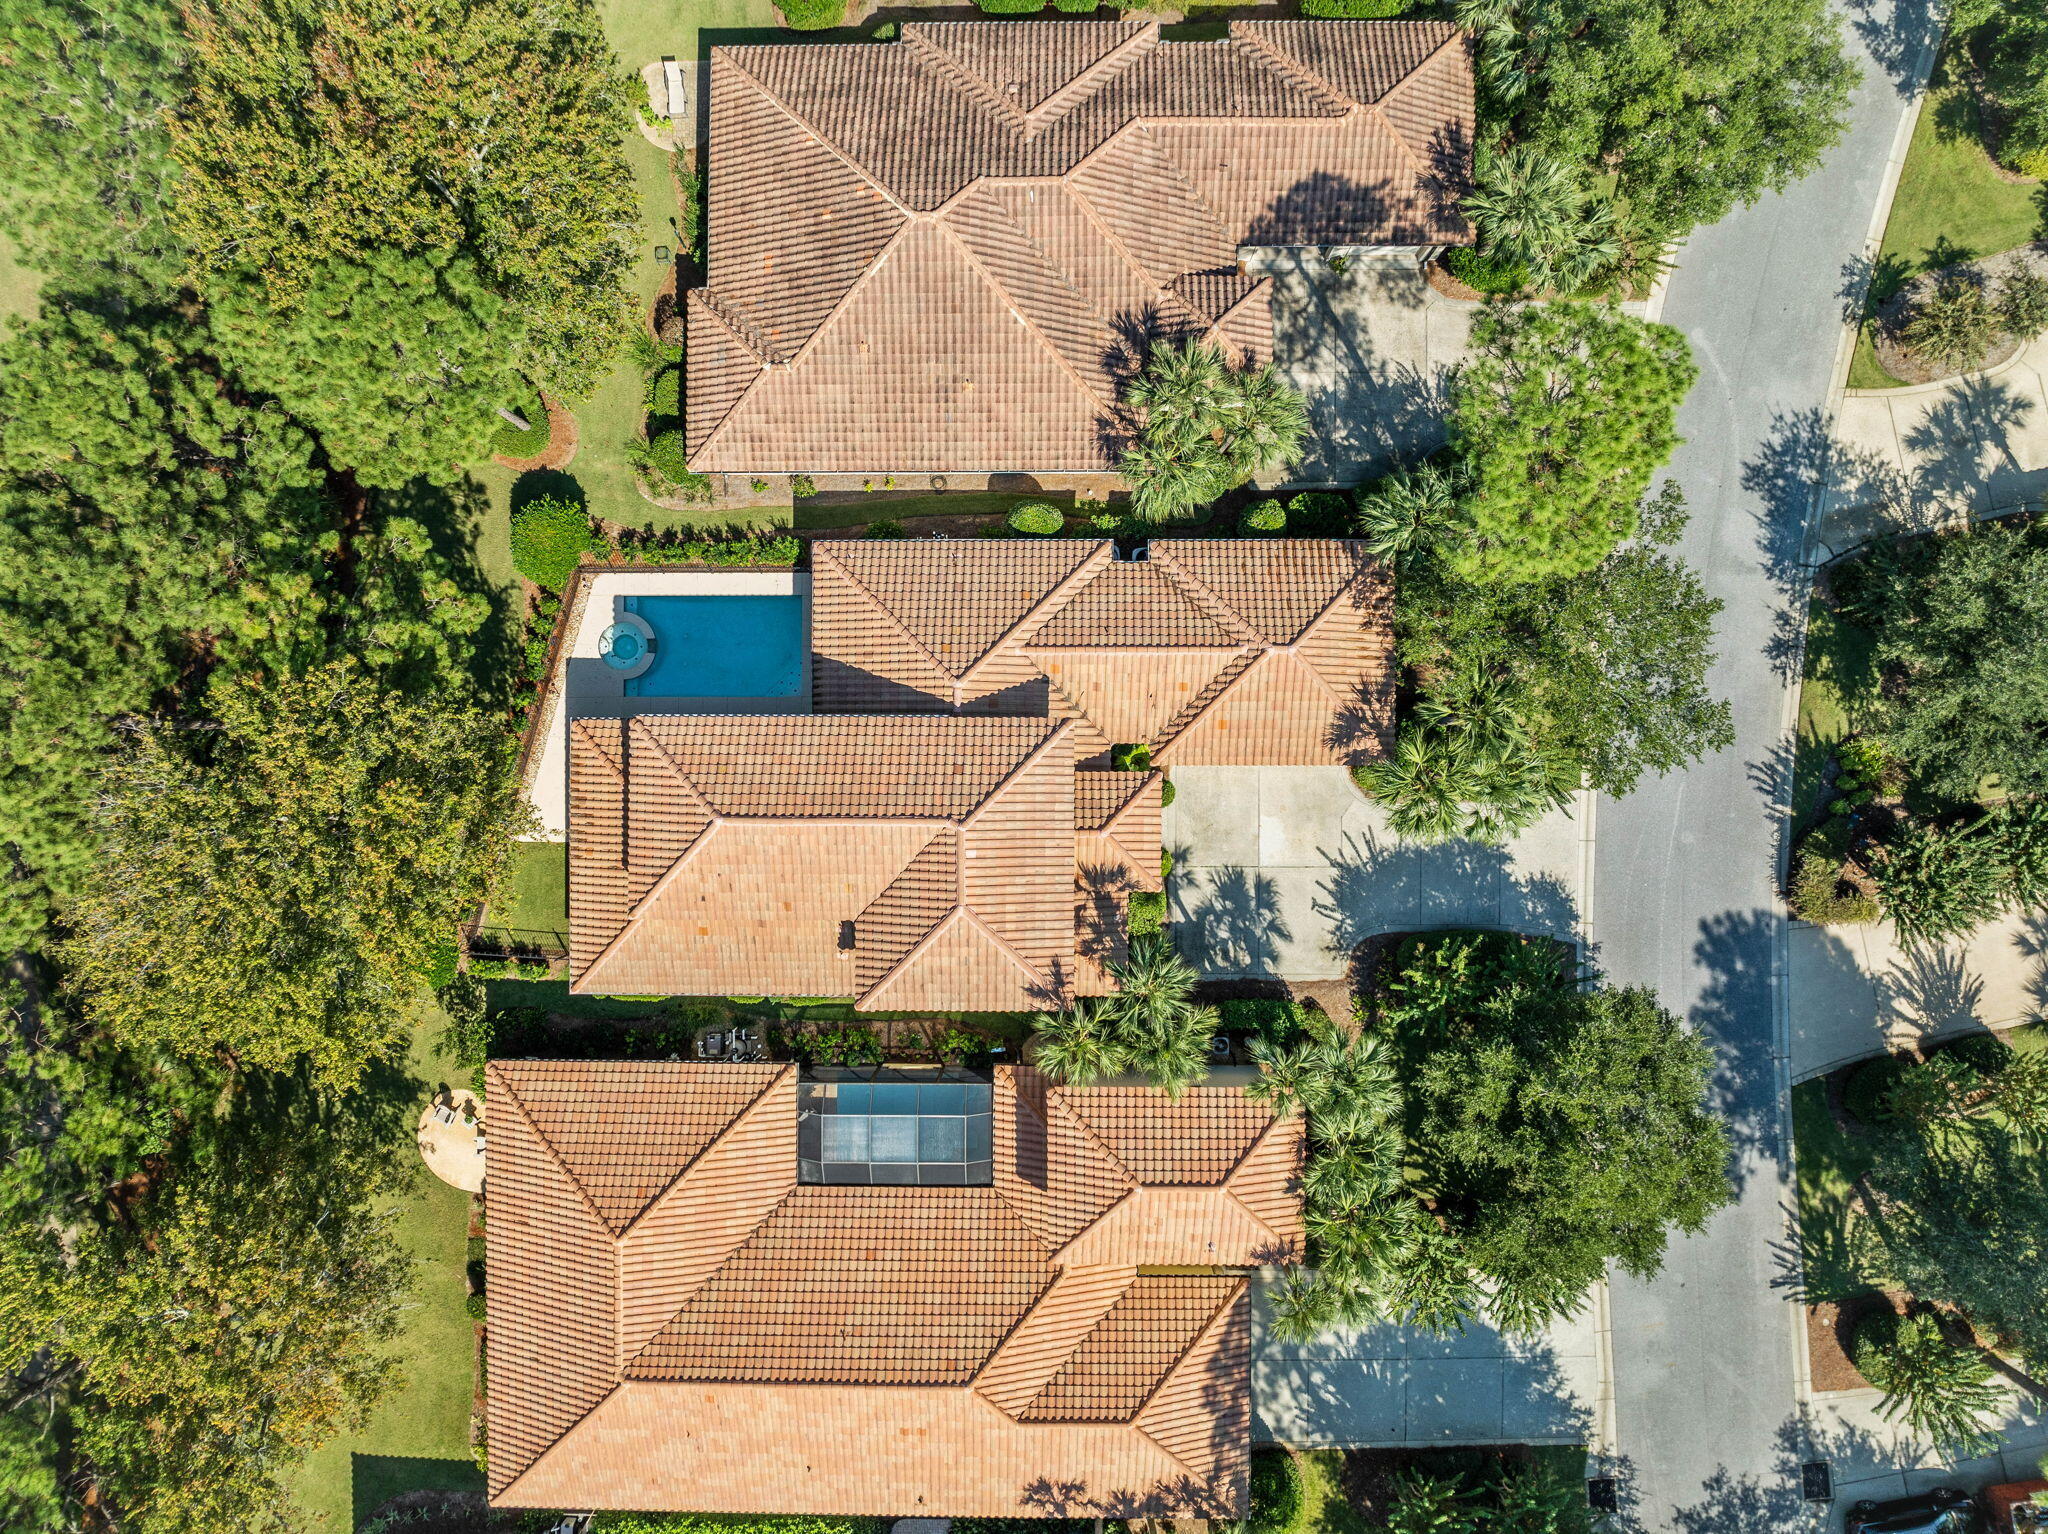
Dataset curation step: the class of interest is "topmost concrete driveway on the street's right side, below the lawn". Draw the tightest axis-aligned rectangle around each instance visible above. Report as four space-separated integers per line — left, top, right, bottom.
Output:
1819 336 2048 559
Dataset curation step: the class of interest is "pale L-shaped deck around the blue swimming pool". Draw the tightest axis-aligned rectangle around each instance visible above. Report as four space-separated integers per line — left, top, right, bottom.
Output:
528 569 811 842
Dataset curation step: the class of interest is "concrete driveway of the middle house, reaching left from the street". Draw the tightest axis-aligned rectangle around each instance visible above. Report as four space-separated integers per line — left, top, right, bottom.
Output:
1163 768 1583 981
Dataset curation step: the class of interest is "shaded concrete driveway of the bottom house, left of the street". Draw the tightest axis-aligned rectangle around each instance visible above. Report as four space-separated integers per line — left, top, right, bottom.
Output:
1251 1290 1606 1448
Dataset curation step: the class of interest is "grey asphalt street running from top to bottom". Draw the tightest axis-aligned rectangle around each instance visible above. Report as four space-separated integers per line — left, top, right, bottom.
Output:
1589 0 1931 1534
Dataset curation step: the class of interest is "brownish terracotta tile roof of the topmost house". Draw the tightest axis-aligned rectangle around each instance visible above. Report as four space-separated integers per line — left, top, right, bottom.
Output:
686 20 1473 473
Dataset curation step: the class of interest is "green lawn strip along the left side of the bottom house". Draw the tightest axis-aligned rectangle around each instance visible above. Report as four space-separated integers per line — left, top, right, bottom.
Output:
293 1006 483 1534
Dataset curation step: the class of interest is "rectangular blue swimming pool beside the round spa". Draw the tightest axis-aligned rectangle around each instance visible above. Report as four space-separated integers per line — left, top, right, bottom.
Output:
621 594 803 698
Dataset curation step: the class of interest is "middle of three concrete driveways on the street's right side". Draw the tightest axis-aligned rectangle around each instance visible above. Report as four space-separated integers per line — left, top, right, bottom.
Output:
1786 911 2048 1081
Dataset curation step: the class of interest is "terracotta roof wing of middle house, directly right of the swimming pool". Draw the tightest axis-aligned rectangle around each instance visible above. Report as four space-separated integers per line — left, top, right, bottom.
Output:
811 539 1393 765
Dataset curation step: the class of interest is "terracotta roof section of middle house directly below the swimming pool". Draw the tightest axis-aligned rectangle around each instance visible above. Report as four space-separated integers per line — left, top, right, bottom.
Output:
569 715 1077 1012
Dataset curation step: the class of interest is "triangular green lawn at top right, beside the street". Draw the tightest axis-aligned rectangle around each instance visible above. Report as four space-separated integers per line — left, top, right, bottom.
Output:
1849 47 2048 389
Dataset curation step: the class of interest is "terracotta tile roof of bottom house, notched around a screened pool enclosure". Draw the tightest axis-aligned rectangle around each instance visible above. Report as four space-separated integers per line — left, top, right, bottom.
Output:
485 1061 1298 1516
